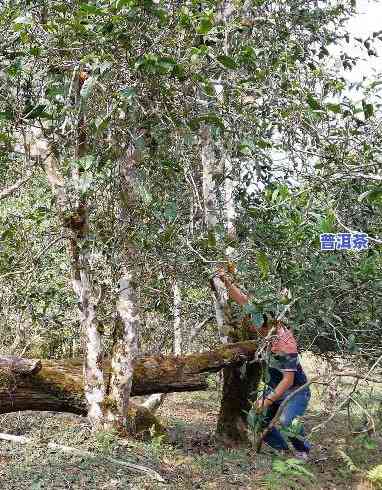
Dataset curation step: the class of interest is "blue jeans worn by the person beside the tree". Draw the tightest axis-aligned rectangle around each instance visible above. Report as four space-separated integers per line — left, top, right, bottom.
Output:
264 388 310 452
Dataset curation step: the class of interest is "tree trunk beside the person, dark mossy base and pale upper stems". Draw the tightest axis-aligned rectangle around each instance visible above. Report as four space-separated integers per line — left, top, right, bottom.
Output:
201 4 260 443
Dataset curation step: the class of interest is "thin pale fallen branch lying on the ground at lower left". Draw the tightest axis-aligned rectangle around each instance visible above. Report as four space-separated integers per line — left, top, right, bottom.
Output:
0 433 166 483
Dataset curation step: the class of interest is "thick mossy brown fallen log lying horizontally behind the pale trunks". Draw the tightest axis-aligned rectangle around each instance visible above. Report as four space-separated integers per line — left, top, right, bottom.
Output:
0 341 256 415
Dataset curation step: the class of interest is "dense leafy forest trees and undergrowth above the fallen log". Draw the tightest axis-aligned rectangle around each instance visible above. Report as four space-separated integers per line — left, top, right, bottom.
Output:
0 0 382 488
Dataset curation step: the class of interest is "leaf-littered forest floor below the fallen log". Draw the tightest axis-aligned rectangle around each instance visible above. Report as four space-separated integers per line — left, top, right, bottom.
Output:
0 374 382 490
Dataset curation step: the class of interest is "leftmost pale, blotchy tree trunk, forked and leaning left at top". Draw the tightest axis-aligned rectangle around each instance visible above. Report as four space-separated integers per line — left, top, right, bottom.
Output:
30 92 105 428
